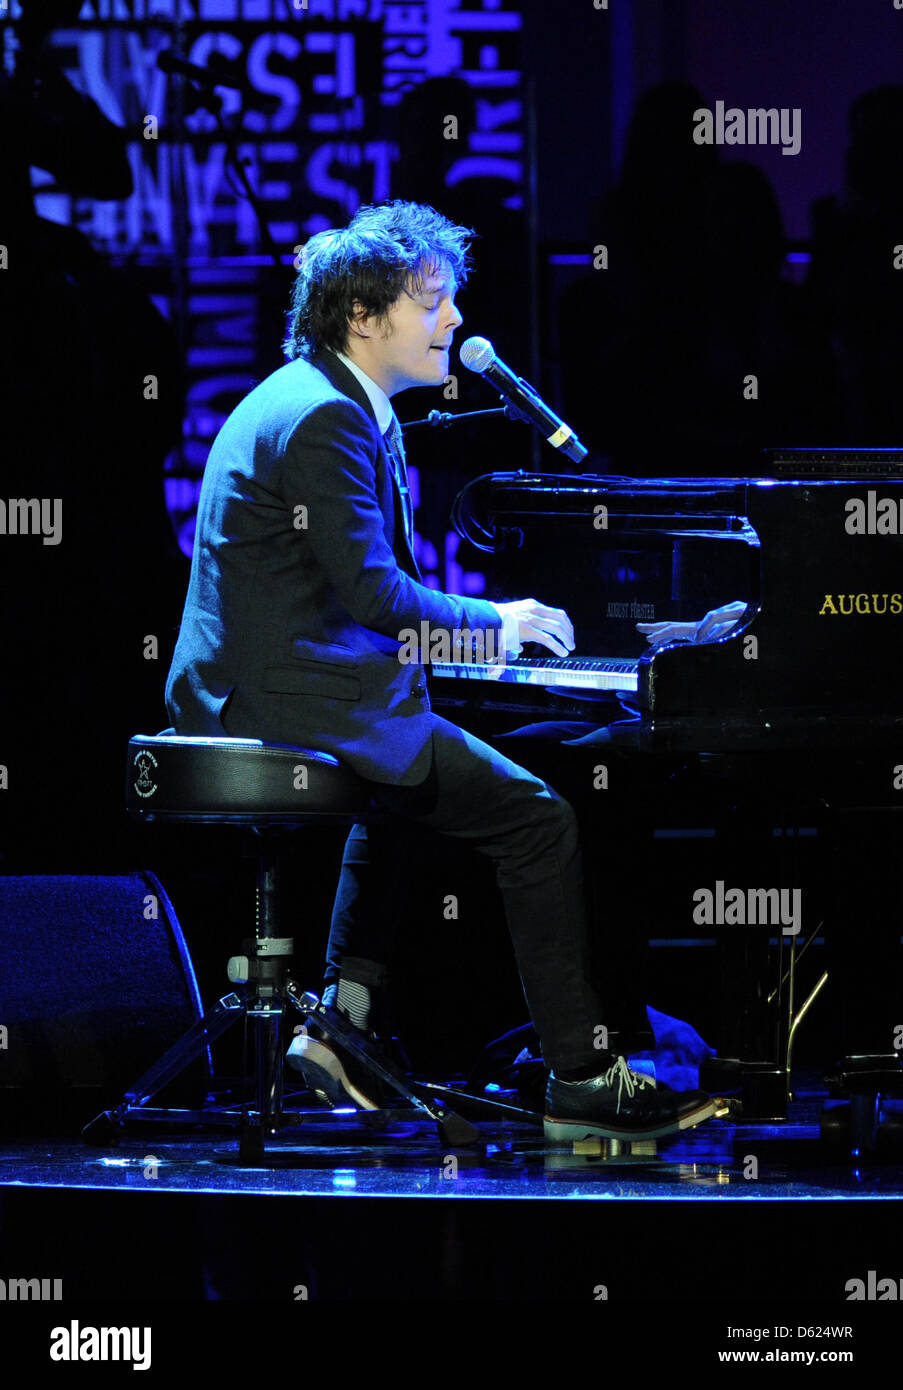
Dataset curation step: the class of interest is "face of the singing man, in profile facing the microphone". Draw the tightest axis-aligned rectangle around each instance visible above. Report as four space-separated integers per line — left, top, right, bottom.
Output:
346 265 464 396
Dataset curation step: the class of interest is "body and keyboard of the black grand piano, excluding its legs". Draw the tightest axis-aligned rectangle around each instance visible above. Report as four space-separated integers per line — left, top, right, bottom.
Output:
432 473 903 752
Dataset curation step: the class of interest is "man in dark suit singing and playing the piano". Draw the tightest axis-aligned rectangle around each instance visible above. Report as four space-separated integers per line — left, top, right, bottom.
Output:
167 202 714 1141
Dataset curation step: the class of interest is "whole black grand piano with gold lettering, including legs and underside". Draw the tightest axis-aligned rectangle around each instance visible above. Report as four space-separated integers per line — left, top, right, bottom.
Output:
429 461 903 1134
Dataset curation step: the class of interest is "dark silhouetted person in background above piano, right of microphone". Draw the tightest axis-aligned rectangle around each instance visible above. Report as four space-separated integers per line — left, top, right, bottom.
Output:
560 82 829 477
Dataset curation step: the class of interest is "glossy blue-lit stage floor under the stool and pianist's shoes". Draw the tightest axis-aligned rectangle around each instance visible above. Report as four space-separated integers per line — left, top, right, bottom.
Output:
0 1093 903 1202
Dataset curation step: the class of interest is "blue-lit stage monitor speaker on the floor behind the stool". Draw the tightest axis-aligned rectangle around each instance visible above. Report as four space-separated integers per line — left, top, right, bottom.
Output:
0 872 213 1134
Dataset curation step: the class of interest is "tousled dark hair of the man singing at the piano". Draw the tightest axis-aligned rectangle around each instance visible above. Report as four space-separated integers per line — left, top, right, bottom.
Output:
283 199 478 359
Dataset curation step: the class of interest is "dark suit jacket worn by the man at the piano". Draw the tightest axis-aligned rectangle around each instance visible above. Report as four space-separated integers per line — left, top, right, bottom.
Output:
165 344 502 785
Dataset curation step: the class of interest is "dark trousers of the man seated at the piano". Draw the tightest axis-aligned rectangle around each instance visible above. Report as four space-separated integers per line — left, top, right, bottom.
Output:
324 714 607 1070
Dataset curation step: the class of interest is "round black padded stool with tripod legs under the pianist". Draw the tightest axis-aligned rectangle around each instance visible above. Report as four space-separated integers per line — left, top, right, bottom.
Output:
82 728 479 1165
